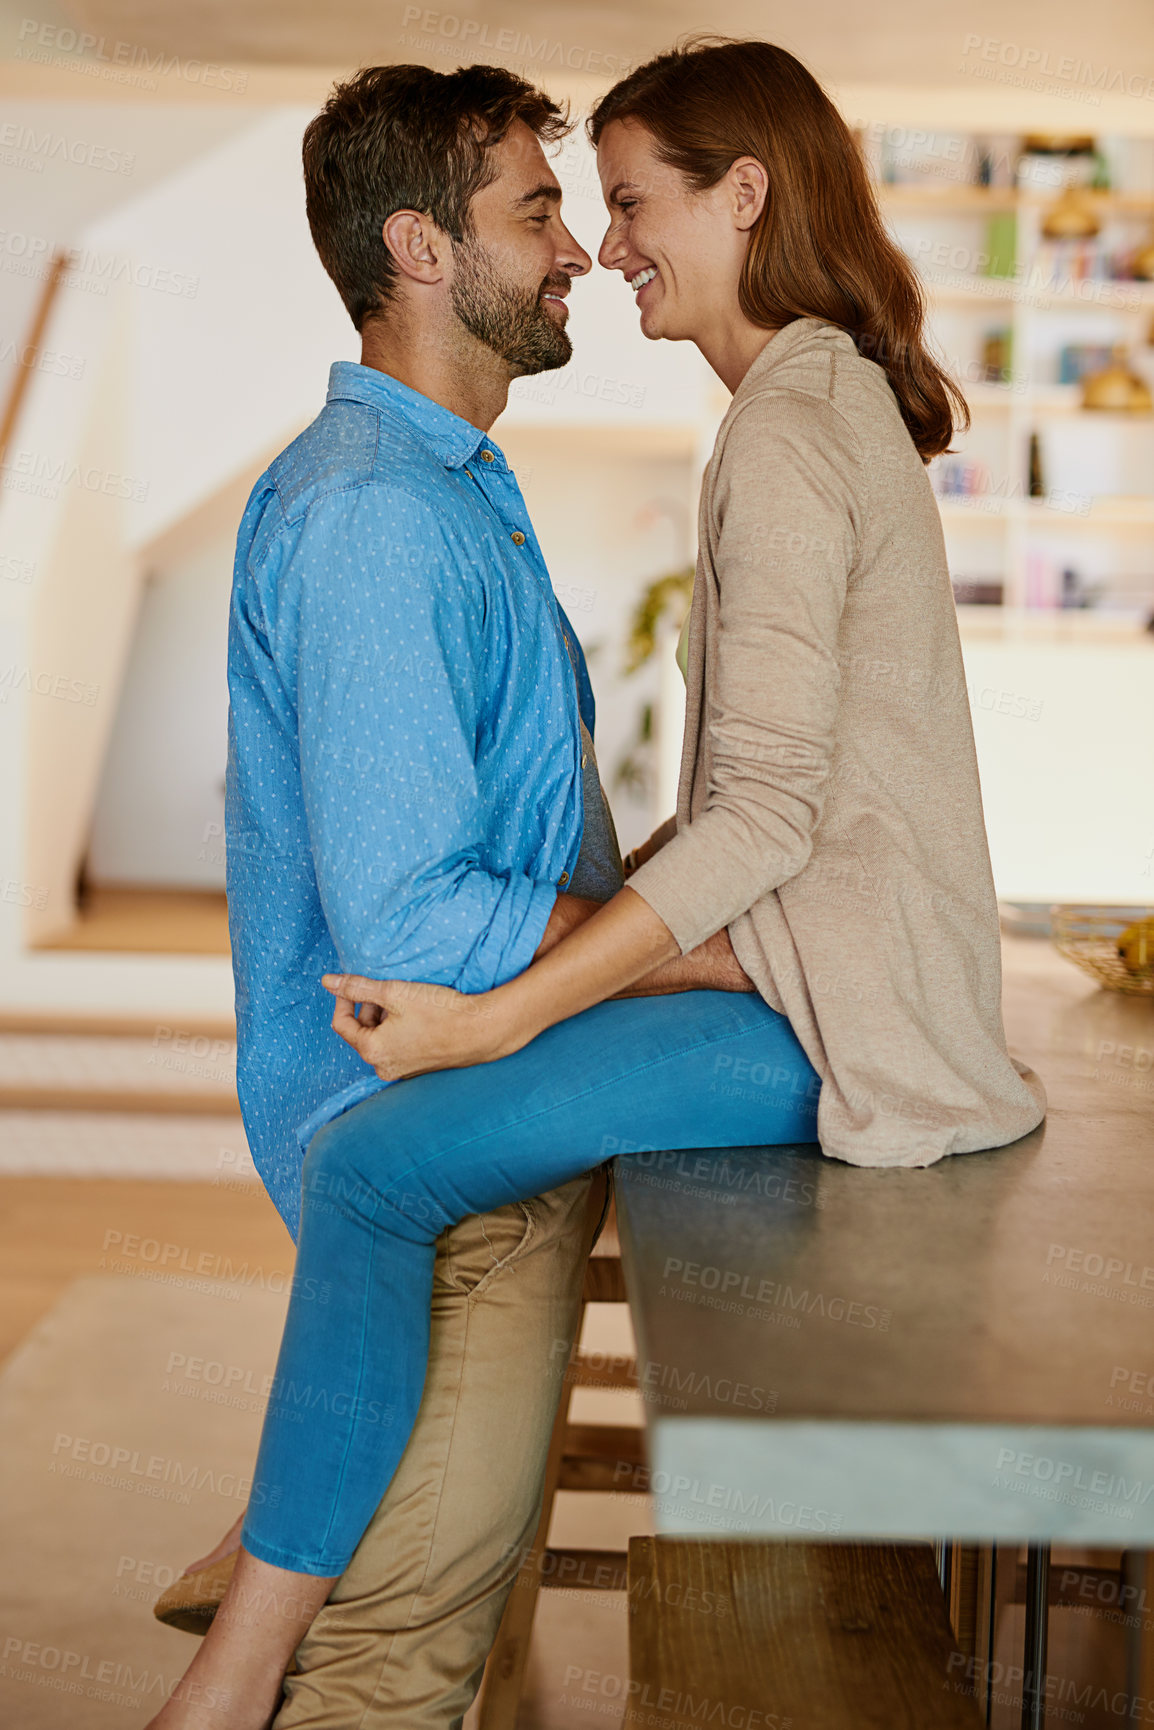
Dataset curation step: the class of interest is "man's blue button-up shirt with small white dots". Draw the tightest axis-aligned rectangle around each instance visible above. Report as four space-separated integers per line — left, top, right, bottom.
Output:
225 362 593 1233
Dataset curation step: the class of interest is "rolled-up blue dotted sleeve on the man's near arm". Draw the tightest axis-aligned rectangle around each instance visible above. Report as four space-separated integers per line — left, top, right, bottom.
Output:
290 486 557 993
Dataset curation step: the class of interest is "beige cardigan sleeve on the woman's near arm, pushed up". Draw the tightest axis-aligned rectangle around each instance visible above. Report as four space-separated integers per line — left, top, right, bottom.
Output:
628 391 862 953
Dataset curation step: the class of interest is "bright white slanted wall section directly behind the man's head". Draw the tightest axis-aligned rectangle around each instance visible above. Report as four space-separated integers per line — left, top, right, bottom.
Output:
87 109 360 545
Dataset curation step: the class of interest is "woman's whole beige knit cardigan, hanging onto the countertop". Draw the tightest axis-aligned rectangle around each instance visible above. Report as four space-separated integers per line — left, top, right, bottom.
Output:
630 318 1045 1166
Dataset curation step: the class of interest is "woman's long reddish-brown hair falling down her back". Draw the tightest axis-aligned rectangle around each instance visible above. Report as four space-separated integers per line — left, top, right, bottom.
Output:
588 38 969 462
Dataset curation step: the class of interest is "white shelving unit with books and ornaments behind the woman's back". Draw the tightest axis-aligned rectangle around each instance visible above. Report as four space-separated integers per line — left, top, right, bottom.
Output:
877 157 1154 618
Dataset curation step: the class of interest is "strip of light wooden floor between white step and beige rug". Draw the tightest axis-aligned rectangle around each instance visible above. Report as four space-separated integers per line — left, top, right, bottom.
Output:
0 1176 294 1360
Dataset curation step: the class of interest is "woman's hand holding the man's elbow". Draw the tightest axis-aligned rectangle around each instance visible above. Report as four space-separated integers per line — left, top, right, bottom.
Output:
320 974 514 1081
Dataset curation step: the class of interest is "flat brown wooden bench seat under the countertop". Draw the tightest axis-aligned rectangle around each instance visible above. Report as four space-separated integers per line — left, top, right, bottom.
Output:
625 1538 984 1730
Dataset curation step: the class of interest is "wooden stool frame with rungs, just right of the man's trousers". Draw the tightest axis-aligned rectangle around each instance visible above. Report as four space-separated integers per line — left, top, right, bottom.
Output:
478 1208 645 1730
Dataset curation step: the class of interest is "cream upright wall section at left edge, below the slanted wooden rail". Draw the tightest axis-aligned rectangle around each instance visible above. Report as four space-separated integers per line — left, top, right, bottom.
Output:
0 268 137 936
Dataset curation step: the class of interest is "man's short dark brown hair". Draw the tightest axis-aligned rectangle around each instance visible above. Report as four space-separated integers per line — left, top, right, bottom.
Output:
303 66 569 330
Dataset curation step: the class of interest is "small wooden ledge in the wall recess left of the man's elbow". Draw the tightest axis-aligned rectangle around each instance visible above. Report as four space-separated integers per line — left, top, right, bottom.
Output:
36 887 228 955
